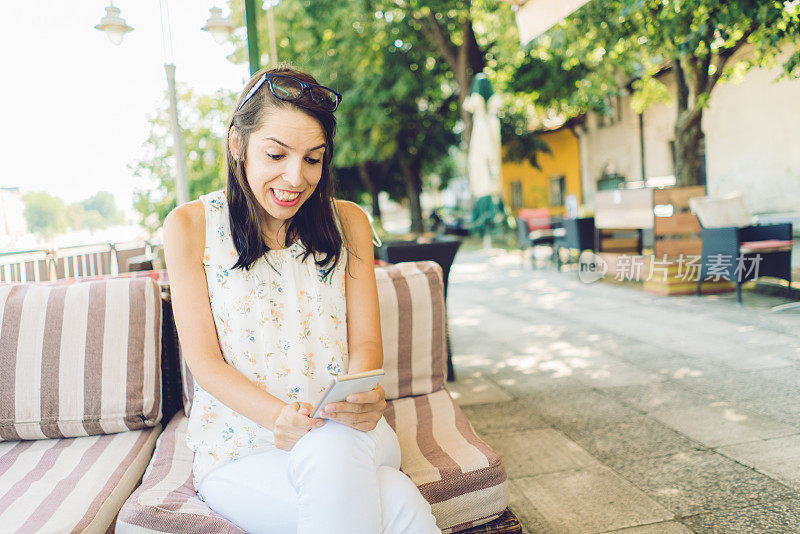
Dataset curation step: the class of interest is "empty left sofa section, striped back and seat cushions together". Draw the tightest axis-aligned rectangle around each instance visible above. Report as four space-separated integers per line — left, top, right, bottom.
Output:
0 278 163 534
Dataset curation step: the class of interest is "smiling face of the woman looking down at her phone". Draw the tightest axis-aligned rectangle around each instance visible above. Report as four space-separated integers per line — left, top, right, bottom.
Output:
245 108 325 230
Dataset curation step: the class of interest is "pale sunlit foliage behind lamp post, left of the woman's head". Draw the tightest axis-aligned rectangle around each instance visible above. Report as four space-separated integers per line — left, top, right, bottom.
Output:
130 86 235 232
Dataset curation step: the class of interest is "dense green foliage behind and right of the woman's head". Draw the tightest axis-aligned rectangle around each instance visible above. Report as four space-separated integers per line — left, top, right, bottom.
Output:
225 0 552 222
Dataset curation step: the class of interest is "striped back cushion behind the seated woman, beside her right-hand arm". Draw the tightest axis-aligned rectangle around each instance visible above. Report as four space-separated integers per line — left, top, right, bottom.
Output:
181 261 447 415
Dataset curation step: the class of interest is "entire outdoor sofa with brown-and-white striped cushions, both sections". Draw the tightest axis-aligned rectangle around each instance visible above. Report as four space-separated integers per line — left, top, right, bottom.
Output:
0 262 521 534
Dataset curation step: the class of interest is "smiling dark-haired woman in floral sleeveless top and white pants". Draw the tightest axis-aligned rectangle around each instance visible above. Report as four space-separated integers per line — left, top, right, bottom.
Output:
164 67 438 534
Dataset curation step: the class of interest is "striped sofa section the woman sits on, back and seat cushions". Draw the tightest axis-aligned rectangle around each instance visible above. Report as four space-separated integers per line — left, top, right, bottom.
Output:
117 262 521 534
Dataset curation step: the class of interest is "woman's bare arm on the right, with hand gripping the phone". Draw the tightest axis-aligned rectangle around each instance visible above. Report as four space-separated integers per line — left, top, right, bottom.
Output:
323 201 386 430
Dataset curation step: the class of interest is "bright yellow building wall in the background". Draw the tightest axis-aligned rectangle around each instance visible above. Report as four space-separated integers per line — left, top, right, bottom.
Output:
500 128 581 216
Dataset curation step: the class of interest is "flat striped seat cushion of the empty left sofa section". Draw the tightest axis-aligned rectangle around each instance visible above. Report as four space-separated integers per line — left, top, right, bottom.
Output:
0 425 161 534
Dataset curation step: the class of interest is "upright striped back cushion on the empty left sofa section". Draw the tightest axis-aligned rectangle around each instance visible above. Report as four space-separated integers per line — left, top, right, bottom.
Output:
0 278 161 441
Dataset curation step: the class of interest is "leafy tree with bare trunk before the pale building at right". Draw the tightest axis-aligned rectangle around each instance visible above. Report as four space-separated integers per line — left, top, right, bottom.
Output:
523 0 800 186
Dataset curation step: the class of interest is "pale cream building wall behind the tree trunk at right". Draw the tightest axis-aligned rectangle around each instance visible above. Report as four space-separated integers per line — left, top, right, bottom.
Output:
578 43 800 214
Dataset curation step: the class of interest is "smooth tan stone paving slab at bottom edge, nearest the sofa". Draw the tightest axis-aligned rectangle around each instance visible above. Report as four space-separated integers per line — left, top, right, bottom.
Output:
514 467 672 534
